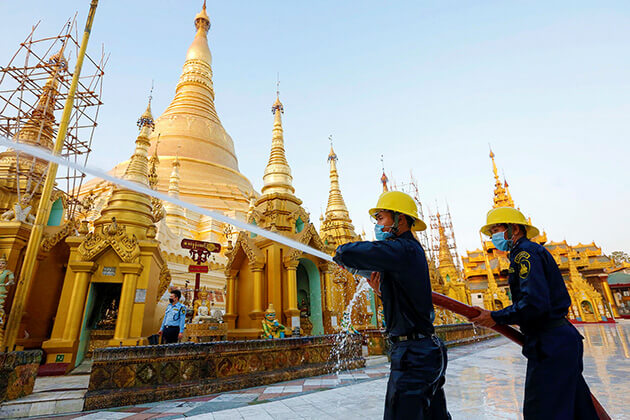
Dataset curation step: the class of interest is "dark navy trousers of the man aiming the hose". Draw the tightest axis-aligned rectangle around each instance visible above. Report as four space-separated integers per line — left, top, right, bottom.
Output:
383 337 451 420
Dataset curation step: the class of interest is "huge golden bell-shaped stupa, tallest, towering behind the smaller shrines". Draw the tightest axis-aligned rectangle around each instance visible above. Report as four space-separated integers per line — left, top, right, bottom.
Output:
81 3 258 308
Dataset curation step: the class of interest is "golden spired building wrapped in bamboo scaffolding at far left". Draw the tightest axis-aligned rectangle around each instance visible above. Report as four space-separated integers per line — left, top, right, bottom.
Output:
0 16 107 220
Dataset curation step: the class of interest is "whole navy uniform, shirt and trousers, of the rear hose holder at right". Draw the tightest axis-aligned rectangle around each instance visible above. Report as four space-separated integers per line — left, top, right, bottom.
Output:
492 238 598 419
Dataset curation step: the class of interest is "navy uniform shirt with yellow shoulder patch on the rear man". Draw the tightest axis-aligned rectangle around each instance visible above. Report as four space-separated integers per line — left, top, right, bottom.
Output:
492 238 571 334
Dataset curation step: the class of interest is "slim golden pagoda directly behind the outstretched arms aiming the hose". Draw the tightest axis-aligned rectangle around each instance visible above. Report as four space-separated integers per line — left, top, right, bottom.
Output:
320 141 376 330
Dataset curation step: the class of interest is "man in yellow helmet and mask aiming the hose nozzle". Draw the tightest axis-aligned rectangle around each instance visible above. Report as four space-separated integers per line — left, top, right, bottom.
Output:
334 191 450 420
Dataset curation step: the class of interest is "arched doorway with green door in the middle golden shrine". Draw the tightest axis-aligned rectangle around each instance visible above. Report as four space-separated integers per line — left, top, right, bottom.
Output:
297 258 324 335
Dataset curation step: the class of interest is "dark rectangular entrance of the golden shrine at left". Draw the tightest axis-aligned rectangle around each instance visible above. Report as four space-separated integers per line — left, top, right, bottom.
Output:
75 283 122 366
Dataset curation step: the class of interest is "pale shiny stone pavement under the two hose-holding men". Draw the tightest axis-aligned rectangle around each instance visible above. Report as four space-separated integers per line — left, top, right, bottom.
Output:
48 321 630 420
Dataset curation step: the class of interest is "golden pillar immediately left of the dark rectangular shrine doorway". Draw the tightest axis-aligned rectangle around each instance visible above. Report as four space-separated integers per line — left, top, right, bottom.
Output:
63 261 98 340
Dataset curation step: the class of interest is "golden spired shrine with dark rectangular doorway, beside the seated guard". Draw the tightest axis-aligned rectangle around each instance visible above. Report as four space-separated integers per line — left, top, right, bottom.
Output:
42 99 170 368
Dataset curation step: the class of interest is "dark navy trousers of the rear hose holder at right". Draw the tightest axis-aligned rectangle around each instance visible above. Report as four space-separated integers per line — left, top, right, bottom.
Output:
523 325 599 420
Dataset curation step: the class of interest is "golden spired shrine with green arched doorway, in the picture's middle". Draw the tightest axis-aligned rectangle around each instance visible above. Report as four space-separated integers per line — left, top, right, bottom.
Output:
223 93 341 339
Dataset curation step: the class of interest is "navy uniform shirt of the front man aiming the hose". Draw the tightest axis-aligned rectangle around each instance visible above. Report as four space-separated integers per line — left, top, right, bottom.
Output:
334 232 434 336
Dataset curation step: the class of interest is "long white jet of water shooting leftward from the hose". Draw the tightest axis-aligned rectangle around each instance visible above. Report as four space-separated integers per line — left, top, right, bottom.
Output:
0 137 333 262
